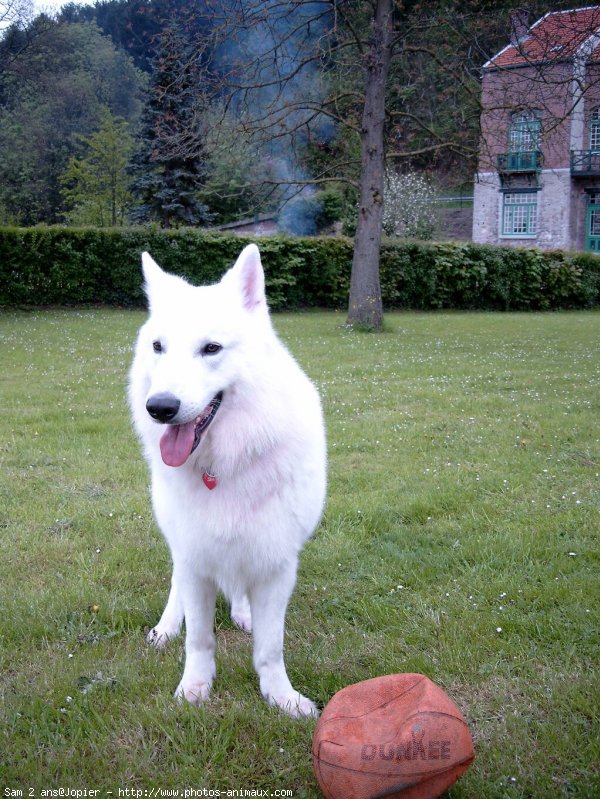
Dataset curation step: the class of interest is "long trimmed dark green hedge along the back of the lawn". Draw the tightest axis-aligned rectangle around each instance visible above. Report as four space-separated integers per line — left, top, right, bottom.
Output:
0 227 600 310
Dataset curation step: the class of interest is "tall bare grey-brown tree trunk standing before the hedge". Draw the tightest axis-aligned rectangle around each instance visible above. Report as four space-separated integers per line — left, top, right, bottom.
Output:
348 0 394 330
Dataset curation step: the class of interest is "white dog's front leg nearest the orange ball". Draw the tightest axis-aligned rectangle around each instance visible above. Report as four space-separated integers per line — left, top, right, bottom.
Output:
250 564 319 718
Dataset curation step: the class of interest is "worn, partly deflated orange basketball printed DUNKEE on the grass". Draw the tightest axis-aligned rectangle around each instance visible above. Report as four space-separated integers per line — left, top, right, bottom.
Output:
312 674 474 799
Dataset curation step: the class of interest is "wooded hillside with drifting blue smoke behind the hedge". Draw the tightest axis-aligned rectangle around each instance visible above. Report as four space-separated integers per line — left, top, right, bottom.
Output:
0 0 584 234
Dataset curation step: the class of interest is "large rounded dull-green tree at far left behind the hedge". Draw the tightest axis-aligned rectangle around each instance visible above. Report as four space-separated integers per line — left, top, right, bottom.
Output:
0 20 144 225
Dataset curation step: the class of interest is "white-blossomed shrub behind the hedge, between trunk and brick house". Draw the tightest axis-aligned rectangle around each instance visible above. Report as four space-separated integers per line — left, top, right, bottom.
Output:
383 169 435 240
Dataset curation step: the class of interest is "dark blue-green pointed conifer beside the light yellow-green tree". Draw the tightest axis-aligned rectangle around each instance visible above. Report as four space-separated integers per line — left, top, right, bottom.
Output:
129 16 210 228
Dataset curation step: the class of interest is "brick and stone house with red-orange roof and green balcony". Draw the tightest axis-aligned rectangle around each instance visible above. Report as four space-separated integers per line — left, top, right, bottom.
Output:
473 6 600 252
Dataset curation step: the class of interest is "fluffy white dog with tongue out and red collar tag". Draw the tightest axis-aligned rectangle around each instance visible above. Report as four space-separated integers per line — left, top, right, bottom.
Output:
129 244 326 716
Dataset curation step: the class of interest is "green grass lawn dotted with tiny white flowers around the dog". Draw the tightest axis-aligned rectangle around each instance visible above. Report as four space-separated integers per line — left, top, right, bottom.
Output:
0 310 600 799
